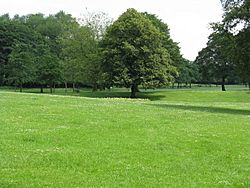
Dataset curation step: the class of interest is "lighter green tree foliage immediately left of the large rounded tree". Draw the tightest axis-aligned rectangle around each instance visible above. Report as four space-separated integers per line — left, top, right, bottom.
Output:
62 26 101 88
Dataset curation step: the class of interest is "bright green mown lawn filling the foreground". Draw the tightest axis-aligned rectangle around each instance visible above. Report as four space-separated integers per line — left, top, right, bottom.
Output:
0 88 250 187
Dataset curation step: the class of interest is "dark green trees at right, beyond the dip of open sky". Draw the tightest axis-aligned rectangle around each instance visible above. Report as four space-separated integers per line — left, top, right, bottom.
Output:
195 0 250 91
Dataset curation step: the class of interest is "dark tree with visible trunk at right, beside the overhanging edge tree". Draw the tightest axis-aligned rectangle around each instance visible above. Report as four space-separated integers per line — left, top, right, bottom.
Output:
195 24 235 91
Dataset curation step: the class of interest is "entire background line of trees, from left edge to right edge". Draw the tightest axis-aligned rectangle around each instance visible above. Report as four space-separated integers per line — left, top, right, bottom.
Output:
0 1 250 97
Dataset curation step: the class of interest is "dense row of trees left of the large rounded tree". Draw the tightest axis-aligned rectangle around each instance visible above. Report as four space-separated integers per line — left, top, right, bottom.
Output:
0 12 110 92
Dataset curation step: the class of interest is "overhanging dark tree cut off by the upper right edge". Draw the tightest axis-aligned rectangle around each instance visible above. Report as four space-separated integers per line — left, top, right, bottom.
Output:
221 0 250 86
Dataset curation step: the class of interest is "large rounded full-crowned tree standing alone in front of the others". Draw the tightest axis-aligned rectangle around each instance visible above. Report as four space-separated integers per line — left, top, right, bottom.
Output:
102 9 175 98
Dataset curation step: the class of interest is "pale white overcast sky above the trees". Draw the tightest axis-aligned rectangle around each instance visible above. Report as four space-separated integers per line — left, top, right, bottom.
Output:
0 0 222 60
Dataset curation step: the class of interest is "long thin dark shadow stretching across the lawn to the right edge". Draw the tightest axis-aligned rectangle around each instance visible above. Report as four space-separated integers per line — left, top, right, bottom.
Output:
150 104 250 115
